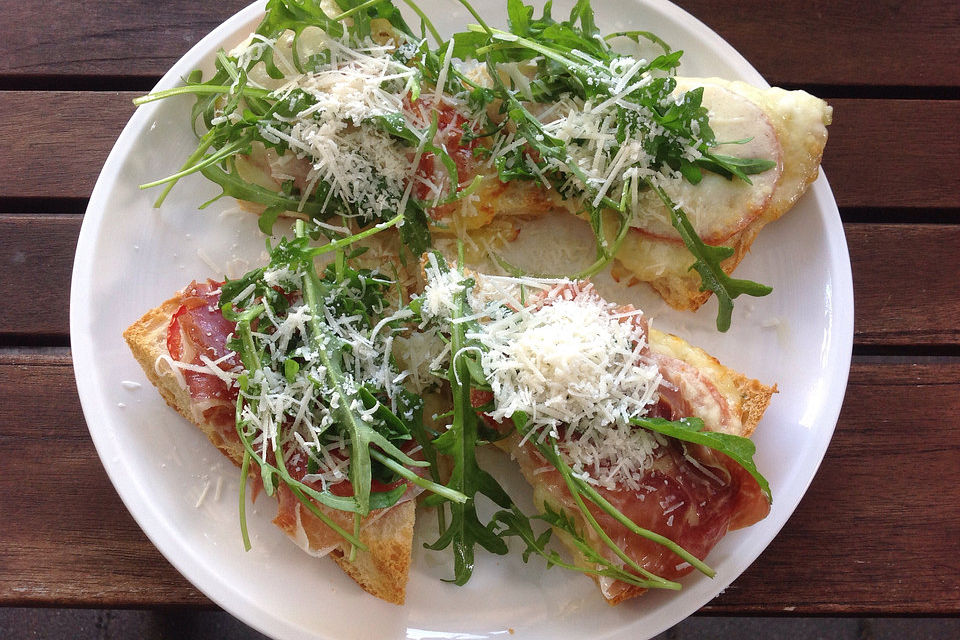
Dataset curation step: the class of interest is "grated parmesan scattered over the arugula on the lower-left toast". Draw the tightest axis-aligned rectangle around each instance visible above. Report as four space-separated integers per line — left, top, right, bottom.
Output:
223 267 422 489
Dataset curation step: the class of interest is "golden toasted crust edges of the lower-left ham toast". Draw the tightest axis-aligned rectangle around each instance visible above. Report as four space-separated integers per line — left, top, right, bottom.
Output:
123 292 416 604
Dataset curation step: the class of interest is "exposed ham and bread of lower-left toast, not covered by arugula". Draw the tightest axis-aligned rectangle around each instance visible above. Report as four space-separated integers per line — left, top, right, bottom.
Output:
124 282 418 604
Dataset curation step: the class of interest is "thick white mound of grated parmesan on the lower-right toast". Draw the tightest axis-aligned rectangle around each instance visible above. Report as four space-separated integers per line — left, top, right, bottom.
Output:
423 256 665 490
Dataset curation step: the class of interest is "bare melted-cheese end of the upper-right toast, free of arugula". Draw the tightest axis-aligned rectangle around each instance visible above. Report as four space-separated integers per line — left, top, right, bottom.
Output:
613 78 833 310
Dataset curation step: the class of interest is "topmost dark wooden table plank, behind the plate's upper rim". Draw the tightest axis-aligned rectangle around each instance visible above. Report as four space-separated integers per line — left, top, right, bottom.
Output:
0 0 960 87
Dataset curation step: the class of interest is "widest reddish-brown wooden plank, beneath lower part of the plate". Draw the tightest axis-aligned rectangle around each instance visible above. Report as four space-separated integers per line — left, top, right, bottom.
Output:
0 355 960 615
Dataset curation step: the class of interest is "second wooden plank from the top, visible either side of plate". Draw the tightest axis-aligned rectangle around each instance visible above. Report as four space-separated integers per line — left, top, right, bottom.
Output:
0 91 960 208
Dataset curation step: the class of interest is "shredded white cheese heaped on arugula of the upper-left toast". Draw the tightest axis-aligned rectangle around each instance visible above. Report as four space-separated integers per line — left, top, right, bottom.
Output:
238 30 416 218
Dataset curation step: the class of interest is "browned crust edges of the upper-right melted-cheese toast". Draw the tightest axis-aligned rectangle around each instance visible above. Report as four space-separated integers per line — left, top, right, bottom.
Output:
612 78 833 311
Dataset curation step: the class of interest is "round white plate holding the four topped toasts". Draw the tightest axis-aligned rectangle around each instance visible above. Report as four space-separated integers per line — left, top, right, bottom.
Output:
70 0 853 639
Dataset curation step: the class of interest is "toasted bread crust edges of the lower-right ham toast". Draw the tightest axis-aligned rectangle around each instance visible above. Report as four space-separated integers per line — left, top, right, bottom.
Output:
496 329 777 605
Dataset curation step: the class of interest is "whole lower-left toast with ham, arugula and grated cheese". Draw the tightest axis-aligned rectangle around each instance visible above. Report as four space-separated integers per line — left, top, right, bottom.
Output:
124 228 465 604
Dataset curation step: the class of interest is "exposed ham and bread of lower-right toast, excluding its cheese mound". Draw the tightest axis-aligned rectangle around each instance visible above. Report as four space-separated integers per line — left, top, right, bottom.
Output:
488 329 775 605
